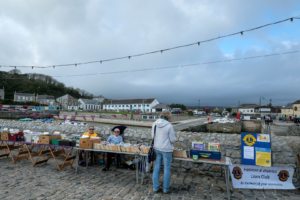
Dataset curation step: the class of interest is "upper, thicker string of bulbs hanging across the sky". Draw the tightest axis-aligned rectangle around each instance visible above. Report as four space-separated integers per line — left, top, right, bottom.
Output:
0 15 300 69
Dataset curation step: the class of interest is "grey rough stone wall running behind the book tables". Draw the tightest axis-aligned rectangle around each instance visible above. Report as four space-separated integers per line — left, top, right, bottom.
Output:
0 120 299 182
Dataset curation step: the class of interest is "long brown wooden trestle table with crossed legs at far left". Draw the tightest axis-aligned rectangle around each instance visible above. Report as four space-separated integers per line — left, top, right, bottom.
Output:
0 140 76 171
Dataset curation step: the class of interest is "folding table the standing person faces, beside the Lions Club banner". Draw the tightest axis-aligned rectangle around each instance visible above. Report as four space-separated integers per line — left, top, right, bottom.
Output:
140 154 232 199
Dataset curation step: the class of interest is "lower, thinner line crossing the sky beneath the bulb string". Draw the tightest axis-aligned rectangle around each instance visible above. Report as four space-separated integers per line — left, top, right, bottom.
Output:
1 51 300 79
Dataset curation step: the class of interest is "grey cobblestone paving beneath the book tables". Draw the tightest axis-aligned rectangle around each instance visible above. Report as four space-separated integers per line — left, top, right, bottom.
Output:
0 158 300 200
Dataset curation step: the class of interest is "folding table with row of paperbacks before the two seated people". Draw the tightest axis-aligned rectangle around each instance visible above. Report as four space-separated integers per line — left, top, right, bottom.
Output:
74 147 139 183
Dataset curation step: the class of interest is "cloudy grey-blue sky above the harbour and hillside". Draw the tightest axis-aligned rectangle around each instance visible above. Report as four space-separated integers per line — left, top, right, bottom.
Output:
0 0 300 106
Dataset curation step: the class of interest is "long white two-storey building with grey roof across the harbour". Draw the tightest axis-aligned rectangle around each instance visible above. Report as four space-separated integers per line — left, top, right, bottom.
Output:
103 98 159 112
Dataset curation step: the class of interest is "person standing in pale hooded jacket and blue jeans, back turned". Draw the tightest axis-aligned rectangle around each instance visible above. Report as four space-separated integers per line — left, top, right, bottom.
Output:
151 110 176 193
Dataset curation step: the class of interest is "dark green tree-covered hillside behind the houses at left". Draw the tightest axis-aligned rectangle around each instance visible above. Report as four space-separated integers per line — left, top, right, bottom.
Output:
0 69 93 99
